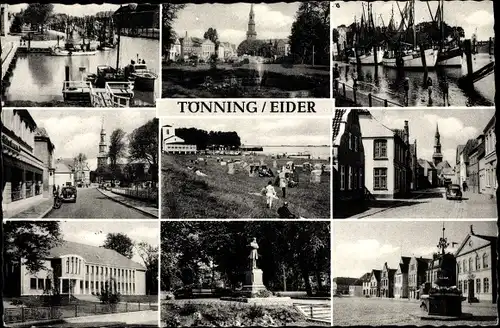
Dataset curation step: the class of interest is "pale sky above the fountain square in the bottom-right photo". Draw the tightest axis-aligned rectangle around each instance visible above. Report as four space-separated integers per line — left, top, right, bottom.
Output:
332 220 497 278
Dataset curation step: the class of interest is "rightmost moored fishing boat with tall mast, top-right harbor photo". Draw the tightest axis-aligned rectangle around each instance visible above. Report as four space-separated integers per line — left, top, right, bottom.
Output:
436 0 463 67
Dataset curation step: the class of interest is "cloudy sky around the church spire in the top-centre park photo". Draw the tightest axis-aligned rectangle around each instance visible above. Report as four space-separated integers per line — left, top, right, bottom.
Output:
173 2 299 46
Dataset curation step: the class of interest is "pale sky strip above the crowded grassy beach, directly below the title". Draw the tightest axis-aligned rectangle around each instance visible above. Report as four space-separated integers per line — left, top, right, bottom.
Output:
160 118 331 146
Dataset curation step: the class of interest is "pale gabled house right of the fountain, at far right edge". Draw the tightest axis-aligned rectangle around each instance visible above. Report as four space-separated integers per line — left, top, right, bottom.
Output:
455 225 498 303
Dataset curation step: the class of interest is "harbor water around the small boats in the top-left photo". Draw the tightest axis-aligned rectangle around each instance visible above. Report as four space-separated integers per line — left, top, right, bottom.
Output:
6 36 161 106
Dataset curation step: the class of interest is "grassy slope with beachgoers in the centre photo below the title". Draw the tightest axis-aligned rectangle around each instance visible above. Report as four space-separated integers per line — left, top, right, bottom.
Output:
162 155 330 218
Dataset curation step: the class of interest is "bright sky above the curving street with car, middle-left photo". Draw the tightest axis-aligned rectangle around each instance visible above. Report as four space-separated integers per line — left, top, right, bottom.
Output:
30 109 156 170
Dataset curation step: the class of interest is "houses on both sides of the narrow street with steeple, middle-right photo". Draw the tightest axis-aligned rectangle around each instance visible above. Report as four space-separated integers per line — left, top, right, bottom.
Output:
332 109 497 208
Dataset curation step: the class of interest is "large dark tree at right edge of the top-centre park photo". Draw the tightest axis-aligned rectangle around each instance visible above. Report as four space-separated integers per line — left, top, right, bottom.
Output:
289 1 330 65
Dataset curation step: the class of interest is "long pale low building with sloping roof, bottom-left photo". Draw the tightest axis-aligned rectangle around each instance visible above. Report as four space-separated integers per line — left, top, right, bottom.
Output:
16 241 146 296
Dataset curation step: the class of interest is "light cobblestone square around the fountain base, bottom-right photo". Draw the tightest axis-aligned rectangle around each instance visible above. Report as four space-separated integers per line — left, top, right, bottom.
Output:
333 296 497 326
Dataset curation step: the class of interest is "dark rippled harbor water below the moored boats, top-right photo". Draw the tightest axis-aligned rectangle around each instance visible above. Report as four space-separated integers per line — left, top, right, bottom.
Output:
339 53 495 106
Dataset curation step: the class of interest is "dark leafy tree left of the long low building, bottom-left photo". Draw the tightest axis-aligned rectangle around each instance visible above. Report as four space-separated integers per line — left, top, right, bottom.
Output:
3 221 62 273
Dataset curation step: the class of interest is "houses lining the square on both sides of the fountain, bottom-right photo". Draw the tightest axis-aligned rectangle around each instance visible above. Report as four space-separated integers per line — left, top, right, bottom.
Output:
333 226 497 303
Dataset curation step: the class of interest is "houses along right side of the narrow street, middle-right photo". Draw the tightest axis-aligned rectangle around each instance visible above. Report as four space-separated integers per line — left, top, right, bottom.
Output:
455 116 498 196
